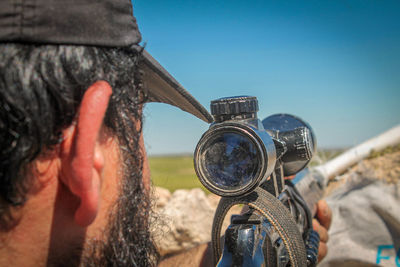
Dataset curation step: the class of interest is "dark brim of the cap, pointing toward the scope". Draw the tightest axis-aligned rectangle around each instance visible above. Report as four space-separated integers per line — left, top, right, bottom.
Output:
135 48 213 123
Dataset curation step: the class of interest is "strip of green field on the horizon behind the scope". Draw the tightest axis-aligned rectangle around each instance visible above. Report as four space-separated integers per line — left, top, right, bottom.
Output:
149 150 343 193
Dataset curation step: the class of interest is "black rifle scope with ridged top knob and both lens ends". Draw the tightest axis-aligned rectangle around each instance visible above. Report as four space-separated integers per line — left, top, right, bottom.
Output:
194 96 315 196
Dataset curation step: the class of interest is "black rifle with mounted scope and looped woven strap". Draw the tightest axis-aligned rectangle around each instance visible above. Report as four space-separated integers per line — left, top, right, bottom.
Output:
194 96 325 266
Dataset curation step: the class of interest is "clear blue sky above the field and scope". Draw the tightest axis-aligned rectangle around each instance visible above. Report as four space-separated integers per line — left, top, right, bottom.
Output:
133 0 400 155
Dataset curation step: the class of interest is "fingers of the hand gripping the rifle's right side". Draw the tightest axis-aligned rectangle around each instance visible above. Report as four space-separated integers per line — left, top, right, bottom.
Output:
313 200 332 262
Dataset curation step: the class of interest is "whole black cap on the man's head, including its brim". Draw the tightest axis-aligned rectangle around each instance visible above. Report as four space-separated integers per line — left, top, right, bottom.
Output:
0 0 212 122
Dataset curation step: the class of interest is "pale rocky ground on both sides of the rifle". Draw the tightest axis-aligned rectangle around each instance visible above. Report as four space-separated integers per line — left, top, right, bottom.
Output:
153 146 400 256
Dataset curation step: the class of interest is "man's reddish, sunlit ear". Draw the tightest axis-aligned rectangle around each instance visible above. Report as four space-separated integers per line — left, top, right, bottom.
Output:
60 81 112 227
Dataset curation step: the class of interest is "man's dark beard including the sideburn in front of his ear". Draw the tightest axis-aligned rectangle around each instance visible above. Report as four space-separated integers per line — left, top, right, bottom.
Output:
80 81 159 267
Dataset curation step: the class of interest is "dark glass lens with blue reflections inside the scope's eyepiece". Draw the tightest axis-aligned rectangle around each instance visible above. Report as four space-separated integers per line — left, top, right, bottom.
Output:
203 132 259 190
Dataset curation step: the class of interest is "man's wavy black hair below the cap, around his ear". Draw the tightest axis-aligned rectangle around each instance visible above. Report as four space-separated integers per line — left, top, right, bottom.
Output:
0 43 143 229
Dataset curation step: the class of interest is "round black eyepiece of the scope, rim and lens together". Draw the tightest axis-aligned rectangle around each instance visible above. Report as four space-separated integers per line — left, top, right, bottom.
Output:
194 122 276 196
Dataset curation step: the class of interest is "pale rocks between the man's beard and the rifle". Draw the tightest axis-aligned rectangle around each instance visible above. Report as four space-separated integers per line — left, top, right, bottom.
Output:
153 187 241 256
